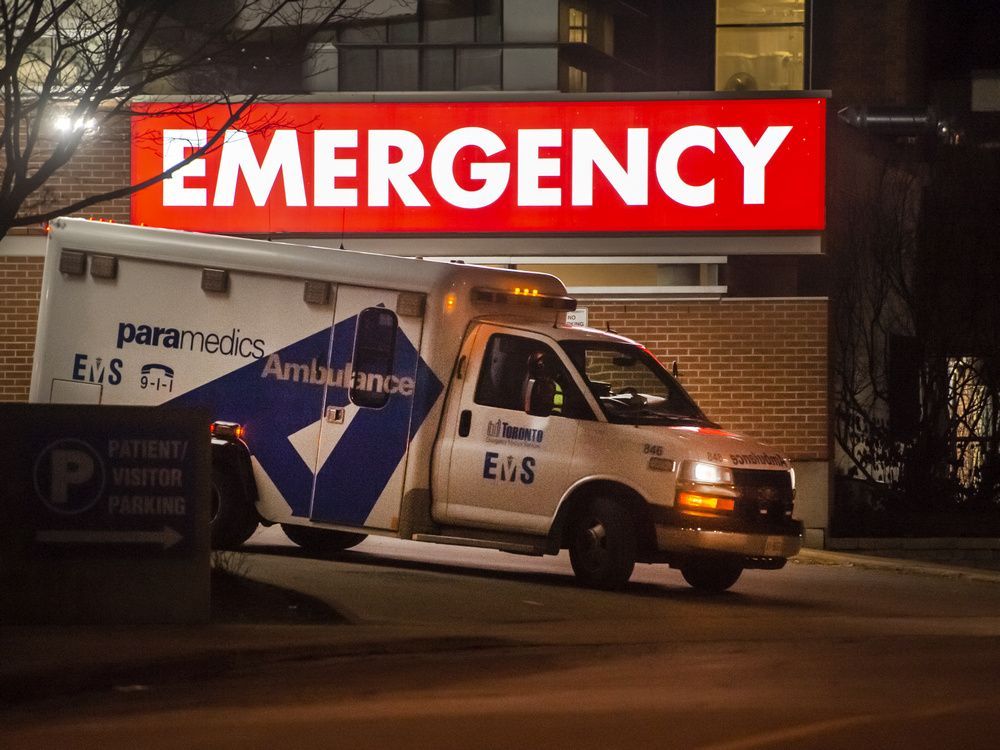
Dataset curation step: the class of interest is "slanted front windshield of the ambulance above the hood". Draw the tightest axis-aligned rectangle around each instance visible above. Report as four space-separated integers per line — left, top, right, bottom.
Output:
562 341 712 425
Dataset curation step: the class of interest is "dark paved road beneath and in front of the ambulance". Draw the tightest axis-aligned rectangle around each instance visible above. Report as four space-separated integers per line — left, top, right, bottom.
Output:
0 530 1000 750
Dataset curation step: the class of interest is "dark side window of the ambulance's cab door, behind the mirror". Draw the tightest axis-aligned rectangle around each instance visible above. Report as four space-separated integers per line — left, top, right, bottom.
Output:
475 333 594 419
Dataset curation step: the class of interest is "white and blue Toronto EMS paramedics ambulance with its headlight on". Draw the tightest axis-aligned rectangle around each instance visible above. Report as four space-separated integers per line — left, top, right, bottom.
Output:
31 219 802 591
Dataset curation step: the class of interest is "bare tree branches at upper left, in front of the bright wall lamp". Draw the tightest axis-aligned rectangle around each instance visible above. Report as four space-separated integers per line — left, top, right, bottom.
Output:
0 0 382 237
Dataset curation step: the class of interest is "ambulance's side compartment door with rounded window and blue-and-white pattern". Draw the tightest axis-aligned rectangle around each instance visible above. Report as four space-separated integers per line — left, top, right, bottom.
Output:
310 286 424 529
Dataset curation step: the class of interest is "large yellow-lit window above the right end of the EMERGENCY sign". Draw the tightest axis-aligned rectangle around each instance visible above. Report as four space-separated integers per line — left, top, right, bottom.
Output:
715 0 805 91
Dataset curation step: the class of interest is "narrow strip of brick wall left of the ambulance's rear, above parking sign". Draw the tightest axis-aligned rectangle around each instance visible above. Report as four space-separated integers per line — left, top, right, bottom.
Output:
0 255 43 401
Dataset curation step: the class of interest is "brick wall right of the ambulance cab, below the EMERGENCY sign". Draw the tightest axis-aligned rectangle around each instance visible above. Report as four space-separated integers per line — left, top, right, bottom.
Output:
583 299 829 460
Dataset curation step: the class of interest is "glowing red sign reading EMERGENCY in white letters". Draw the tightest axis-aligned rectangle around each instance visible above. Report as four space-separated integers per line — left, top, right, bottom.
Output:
132 97 826 235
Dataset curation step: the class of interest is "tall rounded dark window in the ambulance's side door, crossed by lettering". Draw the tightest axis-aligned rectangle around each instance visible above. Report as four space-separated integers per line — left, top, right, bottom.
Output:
350 307 399 409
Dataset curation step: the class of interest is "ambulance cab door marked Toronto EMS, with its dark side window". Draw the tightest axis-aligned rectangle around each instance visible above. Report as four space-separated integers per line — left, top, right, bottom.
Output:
445 325 587 534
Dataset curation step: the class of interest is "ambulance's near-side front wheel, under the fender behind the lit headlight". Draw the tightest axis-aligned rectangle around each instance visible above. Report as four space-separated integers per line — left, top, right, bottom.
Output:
568 497 636 591
